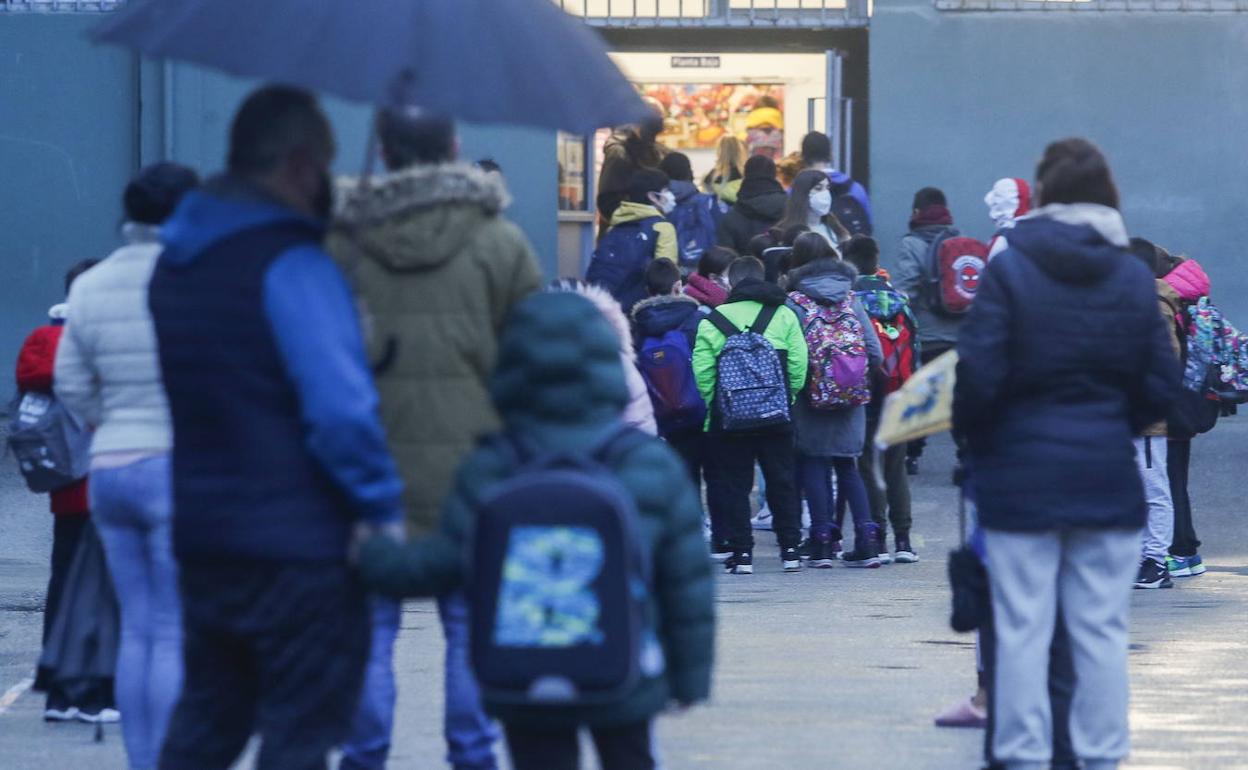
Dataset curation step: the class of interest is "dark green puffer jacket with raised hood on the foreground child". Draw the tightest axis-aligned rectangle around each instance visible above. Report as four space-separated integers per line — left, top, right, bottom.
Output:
359 293 715 726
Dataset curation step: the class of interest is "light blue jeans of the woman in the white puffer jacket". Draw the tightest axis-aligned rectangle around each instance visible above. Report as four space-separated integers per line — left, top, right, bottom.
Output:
90 454 182 770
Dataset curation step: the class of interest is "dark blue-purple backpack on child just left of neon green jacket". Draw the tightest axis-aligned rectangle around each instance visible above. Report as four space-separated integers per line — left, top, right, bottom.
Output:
636 329 706 436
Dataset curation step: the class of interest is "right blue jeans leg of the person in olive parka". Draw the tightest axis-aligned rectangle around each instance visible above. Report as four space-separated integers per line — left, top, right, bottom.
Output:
438 594 499 770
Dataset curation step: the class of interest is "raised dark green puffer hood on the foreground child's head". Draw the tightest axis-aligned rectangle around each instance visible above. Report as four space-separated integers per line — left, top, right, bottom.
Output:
489 291 631 434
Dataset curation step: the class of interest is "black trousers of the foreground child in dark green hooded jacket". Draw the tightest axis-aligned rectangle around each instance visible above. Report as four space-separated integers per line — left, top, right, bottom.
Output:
505 721 658 770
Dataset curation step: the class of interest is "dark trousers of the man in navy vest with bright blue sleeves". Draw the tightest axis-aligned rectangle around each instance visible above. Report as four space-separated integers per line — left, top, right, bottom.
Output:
160 562 369 770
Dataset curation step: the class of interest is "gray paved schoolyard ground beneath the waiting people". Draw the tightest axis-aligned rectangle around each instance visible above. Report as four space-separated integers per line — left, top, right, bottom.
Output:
0 426 1248 770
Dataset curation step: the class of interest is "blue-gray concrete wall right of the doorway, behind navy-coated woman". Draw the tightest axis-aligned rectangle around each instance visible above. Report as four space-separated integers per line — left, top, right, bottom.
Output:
871 0 1248 318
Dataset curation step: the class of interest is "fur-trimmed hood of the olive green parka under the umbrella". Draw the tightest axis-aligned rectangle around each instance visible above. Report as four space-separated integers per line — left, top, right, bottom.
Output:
336 163 510 272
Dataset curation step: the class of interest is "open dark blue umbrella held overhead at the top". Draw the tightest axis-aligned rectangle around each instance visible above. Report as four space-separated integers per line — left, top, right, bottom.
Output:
92 0 646 134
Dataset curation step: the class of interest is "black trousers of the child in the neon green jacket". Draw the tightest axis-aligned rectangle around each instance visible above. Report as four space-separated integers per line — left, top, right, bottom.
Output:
706 432 801 552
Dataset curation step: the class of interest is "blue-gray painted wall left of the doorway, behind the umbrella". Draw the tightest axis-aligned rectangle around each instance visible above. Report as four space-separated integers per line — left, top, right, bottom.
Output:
0 14 558 381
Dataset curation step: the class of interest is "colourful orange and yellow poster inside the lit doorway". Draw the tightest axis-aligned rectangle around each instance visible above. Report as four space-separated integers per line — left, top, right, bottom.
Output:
636 82 784 158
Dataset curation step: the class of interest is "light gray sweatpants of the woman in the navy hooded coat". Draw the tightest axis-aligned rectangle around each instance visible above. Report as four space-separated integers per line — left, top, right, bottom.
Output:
985 529 1139 770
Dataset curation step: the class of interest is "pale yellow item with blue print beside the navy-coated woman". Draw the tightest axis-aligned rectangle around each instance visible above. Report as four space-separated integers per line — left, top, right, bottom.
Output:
875 351 957 449
